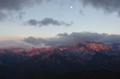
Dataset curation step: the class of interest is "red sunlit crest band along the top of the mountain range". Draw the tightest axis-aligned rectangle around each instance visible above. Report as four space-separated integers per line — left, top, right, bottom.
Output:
0 42 120 56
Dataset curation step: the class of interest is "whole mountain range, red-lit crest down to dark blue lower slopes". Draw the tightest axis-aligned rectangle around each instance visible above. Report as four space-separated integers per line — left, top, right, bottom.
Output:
0 42 120 79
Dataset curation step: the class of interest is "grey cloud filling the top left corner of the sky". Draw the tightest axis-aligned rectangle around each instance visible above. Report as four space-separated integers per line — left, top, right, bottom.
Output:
0 0 43 11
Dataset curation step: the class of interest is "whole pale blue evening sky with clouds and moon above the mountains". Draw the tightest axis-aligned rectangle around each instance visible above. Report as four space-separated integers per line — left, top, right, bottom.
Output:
0 0 120 48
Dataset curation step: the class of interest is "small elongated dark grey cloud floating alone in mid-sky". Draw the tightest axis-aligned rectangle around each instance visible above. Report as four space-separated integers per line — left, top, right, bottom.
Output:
25 18 73 26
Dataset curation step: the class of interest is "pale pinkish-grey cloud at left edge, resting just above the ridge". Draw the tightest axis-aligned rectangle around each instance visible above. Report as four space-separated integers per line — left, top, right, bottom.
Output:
0 40 30 49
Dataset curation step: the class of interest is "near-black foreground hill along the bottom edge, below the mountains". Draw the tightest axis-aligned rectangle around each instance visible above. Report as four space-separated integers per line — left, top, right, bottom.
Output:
25 70 120 79
